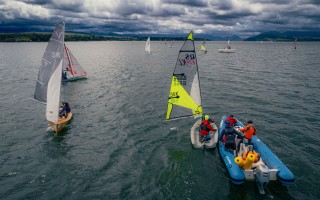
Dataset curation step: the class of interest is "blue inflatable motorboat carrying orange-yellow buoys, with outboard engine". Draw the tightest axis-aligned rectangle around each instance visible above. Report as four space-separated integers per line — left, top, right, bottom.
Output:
218 116 295 194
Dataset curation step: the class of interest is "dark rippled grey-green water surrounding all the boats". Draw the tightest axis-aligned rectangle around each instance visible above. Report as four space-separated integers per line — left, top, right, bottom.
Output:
0 41 320 199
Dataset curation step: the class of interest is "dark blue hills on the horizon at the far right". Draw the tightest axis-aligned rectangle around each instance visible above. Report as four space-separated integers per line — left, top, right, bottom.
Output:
245 31 320 42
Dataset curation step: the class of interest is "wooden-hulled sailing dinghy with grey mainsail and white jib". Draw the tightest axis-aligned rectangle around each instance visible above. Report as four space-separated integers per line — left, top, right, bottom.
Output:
34 22 72 133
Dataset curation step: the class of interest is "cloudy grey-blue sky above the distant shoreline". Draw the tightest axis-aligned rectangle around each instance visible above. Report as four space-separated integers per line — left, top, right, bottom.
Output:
0 0 320 37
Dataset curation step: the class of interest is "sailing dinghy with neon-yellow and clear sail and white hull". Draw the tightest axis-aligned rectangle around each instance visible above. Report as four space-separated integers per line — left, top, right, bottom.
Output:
166 31 218 148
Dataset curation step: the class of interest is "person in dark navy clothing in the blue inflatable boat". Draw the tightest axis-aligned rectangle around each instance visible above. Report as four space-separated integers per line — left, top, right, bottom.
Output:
221 120 243 151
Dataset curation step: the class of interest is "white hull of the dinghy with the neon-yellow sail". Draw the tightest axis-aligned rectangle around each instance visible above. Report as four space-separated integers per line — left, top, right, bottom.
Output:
190 119 218 149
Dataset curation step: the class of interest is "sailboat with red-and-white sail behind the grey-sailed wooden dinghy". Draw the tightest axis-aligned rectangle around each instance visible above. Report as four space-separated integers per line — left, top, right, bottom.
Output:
62 44 87 82
